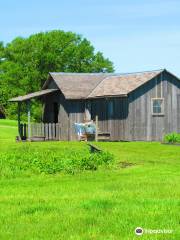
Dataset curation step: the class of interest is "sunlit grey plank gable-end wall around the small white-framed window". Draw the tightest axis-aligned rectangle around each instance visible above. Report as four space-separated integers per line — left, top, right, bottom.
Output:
125 72 180 141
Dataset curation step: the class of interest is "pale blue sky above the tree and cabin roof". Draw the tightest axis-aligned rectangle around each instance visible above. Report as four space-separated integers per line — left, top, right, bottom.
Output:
0 0 180 77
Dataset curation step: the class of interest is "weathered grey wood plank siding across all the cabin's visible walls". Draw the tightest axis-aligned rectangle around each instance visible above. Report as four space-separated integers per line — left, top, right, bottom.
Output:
44 71 180 141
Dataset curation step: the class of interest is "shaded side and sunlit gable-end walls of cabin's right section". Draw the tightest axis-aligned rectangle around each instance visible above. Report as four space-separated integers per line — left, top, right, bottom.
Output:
92 72 180 141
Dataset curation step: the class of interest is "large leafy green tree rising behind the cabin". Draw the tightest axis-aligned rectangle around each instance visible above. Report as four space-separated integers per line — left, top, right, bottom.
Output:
0 31 114 118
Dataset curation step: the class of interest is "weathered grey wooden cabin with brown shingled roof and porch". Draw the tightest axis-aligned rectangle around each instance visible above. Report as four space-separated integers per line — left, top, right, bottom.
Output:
11 69 180 141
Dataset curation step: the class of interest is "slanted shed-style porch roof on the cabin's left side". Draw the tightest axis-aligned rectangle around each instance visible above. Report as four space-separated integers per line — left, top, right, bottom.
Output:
9 89 59 102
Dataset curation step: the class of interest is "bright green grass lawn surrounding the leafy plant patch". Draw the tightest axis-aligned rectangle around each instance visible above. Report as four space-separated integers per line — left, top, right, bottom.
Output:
0 120 180 240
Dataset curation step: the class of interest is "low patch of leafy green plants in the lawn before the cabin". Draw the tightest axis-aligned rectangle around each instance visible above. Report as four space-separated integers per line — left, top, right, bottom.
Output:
0 147 113 176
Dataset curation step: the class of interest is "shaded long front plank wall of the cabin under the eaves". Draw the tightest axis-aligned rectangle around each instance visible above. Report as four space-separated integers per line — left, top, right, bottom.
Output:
43 74 128 140
